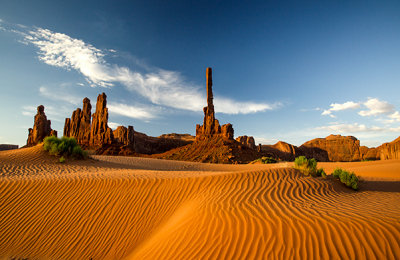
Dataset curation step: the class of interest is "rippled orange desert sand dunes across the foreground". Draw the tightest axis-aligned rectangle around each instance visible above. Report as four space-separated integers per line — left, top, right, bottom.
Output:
0 145 400 259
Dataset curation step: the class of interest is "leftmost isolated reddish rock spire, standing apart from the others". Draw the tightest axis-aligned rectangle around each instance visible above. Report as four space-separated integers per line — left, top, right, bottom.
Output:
26 105 57 146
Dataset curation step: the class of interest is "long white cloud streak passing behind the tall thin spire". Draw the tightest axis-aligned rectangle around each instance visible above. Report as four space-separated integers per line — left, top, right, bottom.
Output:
19 28 280 114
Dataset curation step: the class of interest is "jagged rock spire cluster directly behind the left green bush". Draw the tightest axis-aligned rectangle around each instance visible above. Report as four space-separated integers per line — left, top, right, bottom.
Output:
64 98 92 147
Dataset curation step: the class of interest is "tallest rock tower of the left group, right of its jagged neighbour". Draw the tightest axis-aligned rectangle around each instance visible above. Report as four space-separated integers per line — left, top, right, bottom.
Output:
89 93 114 147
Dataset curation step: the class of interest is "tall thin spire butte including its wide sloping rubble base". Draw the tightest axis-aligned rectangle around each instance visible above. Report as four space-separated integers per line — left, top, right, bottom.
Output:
153 68 260 163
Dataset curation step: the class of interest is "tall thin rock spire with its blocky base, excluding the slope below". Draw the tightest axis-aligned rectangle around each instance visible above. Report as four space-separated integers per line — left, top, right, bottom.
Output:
196 68 234 140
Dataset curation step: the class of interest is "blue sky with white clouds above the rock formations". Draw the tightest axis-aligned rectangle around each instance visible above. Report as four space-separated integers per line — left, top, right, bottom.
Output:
0 0 400 147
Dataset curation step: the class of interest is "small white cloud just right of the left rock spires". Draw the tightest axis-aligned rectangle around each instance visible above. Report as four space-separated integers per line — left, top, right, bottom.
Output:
107 103 157 119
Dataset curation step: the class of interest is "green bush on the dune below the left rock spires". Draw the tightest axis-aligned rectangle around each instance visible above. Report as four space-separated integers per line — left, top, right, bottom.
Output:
43 136 87 162
